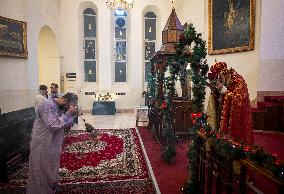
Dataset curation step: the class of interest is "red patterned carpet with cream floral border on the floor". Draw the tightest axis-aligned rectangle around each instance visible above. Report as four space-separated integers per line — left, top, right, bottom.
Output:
0 129 155 194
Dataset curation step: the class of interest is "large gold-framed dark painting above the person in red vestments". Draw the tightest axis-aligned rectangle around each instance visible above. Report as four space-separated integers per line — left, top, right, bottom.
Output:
208 0 255 55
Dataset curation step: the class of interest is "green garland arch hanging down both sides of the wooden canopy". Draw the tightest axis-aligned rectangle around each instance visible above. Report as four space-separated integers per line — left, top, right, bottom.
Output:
163 24 209 164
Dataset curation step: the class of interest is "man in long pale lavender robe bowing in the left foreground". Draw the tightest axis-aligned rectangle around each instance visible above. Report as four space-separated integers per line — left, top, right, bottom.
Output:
27 93 77 194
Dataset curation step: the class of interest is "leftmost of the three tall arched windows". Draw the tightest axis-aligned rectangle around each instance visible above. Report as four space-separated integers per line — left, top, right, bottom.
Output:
83 8 97 82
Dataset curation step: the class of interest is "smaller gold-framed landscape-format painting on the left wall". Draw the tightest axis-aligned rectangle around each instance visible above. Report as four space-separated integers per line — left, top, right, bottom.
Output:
0 16 28 58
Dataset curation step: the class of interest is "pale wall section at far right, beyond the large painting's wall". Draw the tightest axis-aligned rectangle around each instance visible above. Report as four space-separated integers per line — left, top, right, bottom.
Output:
258 0 284 91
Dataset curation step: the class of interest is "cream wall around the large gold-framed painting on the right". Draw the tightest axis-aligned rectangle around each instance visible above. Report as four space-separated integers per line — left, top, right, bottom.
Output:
176 0 261 103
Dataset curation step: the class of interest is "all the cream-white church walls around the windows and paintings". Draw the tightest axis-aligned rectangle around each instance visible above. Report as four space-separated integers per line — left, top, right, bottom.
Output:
0 0 284 112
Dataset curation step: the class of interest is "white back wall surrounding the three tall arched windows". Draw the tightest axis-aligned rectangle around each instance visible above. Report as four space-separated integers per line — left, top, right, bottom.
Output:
60 0 171 110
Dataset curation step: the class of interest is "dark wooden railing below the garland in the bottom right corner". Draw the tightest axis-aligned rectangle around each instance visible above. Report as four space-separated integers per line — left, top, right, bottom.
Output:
195 134 284 194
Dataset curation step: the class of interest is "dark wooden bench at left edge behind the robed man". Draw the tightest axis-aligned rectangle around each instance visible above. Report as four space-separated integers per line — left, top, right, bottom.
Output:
0 108 35 182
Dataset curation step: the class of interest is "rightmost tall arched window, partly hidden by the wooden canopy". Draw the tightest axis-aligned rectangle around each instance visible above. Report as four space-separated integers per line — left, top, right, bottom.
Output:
144 11 157 82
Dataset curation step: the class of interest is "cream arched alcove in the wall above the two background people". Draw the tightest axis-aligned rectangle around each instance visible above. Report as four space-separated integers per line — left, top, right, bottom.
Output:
38 26 61 91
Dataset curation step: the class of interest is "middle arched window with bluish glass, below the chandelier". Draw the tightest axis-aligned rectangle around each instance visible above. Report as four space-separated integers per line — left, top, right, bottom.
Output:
114 10 127 82
